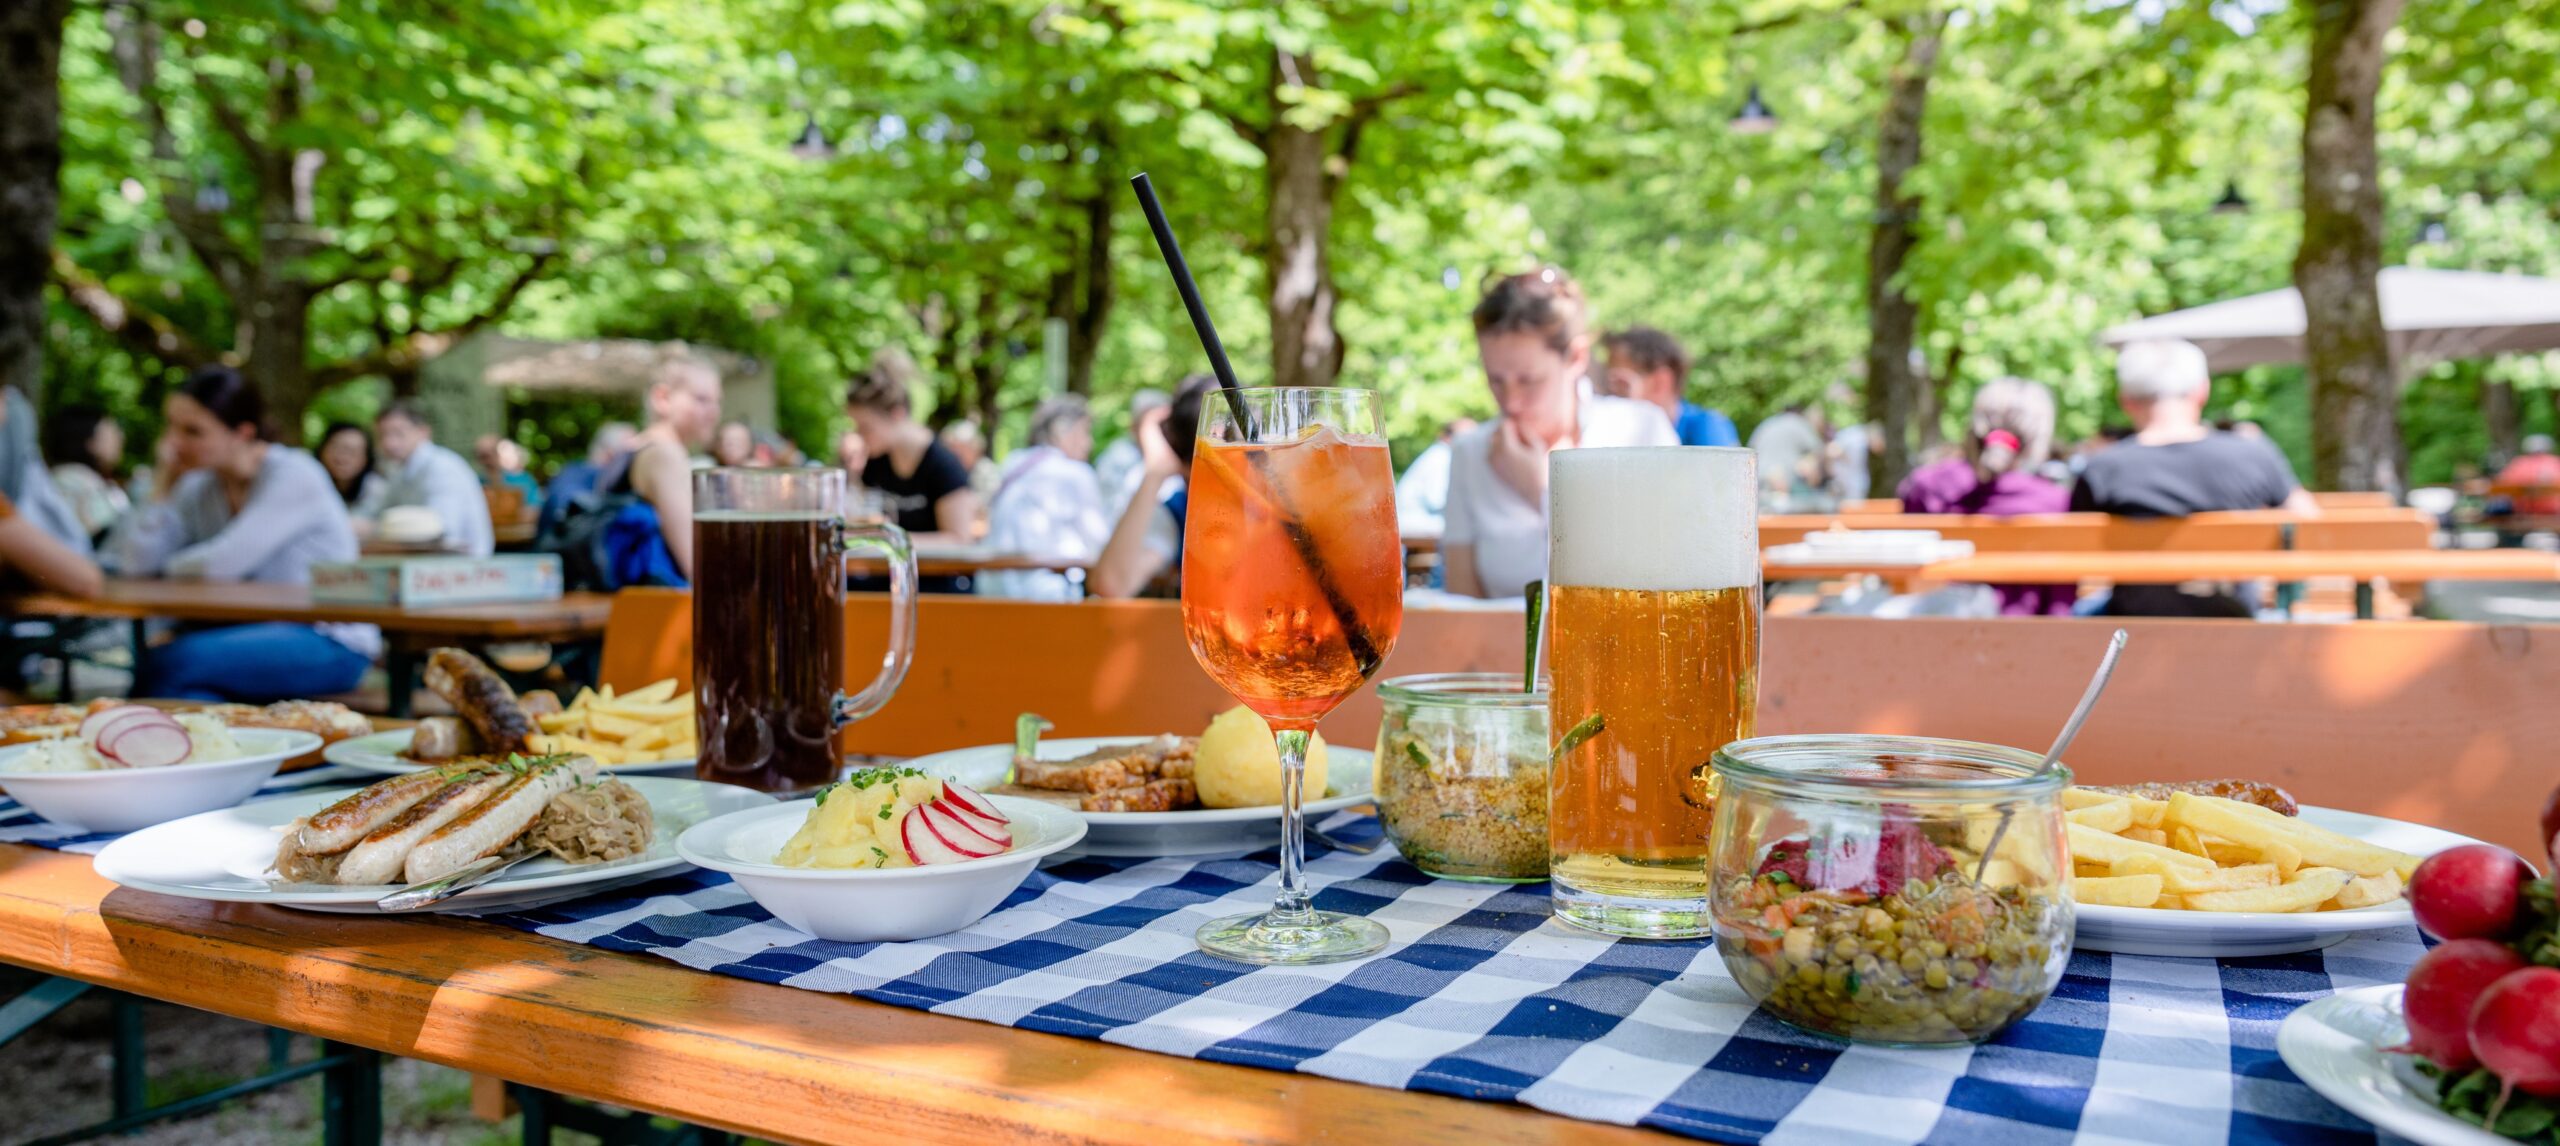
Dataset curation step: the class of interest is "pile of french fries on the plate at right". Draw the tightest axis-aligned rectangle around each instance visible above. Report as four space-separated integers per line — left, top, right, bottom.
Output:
2061 788 2419 913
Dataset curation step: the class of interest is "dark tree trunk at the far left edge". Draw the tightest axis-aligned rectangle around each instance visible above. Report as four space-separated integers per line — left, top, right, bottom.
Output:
0 0 72 402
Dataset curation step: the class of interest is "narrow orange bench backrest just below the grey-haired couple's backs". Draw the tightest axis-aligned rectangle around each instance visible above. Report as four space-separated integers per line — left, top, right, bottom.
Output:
1759 509 2435 553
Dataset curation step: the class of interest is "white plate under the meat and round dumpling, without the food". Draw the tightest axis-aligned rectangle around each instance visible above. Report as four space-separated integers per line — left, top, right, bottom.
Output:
909 734 1370 854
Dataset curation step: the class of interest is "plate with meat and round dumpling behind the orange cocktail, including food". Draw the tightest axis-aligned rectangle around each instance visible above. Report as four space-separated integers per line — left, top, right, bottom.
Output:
909 709 1370 854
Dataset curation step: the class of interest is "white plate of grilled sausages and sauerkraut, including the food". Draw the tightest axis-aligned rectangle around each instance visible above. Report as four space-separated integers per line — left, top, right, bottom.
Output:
97 767 773 913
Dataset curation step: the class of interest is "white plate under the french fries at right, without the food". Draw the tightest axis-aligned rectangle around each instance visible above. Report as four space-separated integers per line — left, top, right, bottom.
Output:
2074 806 2478 959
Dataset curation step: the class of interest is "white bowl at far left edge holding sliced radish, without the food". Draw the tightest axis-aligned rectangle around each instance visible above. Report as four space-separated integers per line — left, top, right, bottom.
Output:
0 729 320 831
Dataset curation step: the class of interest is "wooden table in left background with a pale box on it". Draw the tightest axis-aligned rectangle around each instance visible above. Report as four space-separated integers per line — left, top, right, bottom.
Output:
0 578 612 716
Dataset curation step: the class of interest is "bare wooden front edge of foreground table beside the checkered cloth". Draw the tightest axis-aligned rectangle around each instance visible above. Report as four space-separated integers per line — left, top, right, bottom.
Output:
0 844 1664 1146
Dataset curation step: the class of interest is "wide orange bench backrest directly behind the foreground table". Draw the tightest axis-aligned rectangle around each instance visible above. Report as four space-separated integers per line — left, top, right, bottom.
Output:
604 591 2560 854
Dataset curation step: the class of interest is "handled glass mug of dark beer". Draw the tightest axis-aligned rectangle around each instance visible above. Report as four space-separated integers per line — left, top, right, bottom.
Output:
694 468 916 793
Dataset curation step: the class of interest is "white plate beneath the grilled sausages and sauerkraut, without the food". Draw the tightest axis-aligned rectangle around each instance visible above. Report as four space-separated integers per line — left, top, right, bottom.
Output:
97 775 773 913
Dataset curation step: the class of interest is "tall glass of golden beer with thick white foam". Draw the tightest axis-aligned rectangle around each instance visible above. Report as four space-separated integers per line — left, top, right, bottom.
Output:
1546 448 1759 939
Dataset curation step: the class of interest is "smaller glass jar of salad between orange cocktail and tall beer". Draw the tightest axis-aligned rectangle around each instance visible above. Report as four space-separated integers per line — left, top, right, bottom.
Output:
1375 673 1549 883
